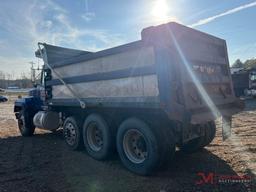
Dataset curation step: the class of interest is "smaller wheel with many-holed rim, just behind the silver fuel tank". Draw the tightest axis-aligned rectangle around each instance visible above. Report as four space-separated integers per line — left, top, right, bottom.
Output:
63 117 83 150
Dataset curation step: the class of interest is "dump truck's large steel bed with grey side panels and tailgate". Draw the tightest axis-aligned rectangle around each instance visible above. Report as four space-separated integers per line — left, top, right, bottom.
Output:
40 23 241 124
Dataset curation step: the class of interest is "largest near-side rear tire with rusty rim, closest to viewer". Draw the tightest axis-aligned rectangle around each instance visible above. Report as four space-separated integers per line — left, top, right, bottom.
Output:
116 118 172 175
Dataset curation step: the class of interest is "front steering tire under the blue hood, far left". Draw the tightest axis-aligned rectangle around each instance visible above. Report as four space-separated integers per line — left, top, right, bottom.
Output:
18 110 35 137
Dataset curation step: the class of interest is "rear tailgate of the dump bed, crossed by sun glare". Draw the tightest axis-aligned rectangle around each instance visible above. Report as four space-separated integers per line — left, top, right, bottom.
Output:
170 25 241 123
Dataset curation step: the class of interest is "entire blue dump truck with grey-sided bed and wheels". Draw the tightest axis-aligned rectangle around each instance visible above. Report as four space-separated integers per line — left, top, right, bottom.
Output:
14 22 243 175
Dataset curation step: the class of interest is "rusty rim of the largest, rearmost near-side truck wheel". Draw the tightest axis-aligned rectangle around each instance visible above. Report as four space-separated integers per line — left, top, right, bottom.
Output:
123 129 148 164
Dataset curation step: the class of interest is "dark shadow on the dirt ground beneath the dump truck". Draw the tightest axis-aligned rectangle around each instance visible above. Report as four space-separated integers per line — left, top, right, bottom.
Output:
0 131 252 192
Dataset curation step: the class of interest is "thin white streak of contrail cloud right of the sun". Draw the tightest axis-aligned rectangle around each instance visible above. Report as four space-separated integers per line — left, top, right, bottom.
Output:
190 1 256 27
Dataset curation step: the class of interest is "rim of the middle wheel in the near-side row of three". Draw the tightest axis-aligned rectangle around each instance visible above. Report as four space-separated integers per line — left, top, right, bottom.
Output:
86 122 103 151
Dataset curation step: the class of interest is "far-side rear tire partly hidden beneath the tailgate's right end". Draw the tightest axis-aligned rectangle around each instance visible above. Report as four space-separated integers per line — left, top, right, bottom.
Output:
180 121 216 153
